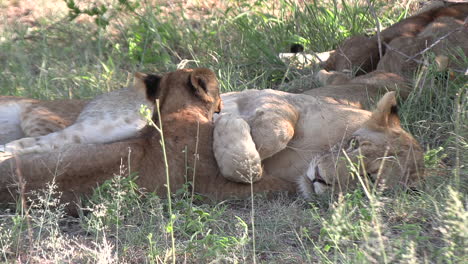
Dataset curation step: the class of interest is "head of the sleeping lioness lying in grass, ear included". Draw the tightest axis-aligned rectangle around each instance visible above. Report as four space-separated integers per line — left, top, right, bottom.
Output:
299 92 424 197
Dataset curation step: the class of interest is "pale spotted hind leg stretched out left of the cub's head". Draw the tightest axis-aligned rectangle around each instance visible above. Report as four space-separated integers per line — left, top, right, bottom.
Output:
0 73 160 154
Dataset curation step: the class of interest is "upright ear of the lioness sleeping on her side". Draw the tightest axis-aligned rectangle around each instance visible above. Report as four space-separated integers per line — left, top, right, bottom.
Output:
368 92 400 127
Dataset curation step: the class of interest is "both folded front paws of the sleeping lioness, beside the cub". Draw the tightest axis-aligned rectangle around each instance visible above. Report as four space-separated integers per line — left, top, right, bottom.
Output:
213 105 298 183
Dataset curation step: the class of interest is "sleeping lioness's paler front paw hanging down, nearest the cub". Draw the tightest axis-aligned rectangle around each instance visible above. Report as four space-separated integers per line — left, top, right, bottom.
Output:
213 113 263 183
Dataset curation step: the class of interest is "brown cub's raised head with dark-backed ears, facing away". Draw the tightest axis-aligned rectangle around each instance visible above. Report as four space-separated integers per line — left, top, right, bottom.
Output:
134 68 222 120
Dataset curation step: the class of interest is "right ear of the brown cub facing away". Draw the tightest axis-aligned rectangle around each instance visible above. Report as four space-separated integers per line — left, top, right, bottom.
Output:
189 68 219 103
